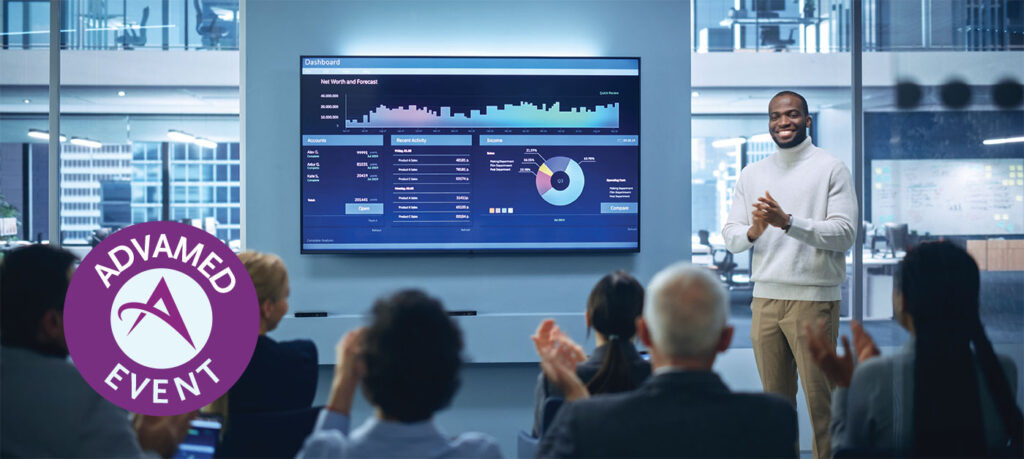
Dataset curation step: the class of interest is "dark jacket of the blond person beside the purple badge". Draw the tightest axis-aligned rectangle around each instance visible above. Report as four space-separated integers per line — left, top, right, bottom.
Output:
227 335 317 413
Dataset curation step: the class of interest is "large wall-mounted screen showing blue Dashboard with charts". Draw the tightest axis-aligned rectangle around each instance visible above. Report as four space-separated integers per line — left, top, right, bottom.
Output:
300 56 640 253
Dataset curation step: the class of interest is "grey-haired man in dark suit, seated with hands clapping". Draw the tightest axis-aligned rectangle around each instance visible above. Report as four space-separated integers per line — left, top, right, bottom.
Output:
535 263 797 457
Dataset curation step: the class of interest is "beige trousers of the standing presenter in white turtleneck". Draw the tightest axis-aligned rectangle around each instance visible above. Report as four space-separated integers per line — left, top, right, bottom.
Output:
751 298 839 459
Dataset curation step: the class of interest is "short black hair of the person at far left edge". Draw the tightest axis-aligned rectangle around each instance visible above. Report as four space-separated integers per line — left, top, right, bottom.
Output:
0 244 77 348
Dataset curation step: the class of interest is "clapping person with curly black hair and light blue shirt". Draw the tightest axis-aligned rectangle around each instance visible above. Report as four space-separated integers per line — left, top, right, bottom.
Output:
299 290 501 458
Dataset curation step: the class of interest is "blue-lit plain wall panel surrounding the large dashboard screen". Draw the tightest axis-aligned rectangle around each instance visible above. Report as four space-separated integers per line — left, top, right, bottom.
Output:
241 0 690 362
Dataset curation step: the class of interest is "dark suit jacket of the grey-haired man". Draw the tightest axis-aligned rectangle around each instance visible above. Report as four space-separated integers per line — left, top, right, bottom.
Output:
538 371 797 457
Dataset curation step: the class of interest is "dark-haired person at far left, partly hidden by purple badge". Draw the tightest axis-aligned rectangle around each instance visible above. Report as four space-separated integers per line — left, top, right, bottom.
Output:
0 245 194 457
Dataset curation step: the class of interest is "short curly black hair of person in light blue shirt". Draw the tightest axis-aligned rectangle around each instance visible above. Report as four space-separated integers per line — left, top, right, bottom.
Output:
362 290 463 422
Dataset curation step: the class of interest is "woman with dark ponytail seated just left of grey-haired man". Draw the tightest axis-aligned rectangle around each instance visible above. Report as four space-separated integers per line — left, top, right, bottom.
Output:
534 270 650 436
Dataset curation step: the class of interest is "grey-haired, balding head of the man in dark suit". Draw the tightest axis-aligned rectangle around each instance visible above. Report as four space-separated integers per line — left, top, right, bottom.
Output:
643 262 728 359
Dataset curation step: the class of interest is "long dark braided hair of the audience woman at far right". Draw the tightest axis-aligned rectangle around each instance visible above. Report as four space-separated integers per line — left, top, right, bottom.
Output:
896 242 1024 457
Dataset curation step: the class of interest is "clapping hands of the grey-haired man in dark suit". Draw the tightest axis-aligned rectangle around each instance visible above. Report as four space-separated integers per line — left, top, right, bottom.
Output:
530 319 590 402
